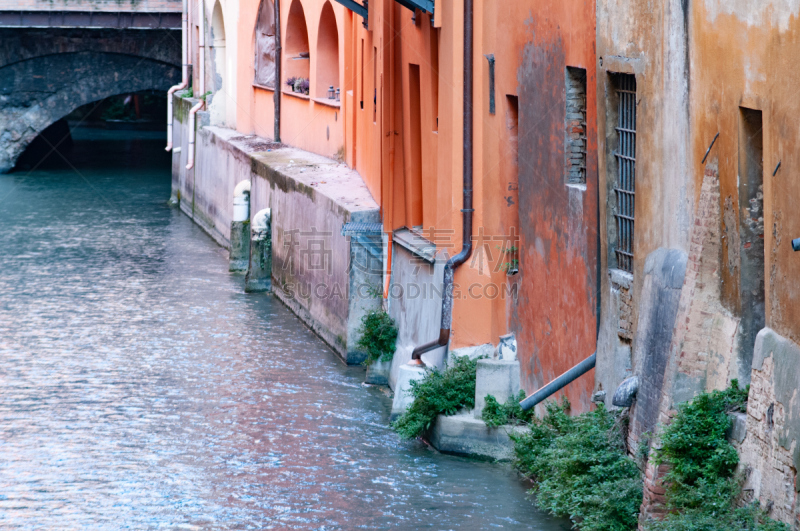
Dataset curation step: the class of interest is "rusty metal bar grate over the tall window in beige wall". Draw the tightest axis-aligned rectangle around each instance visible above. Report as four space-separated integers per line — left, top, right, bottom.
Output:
614 74 636 273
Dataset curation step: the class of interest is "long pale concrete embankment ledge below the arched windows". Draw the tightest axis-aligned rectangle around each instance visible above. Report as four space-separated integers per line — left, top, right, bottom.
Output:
172 92 383 364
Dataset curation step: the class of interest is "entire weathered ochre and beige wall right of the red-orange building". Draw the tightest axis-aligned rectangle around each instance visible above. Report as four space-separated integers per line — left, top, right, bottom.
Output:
597 0 800 523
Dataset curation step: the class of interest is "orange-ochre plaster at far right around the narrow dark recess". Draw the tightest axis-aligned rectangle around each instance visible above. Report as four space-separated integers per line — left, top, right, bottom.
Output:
691 0 800 352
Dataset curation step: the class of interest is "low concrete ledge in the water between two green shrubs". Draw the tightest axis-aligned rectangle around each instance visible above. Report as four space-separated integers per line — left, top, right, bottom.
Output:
427 411 528 461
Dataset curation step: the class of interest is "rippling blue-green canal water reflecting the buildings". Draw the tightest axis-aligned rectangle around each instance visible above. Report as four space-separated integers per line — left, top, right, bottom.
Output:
0 129 569 531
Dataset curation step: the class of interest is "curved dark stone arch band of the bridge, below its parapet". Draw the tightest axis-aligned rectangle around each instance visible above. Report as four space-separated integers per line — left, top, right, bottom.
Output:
0 51 181 173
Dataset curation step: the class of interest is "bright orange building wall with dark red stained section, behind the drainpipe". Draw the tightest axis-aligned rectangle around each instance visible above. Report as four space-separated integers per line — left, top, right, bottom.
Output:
345 0 598 411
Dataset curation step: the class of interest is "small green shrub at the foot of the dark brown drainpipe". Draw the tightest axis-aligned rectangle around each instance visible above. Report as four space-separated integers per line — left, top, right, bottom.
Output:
392 356 478 439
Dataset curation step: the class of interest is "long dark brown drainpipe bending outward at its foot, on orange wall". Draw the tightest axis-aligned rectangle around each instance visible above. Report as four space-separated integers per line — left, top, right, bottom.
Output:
408 0 474 365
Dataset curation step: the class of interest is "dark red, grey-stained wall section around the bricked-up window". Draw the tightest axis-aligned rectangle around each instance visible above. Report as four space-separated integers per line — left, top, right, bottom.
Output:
498 0 599 412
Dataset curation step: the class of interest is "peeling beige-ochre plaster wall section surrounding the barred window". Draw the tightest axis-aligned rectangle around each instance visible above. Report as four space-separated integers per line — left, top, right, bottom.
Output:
595 0 695 412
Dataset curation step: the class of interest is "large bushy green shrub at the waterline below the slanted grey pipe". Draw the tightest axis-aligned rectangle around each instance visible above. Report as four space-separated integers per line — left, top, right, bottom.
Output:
511 399 642 531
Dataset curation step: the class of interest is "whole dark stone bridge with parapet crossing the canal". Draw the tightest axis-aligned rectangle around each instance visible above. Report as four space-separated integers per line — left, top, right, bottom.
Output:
0 0 181 173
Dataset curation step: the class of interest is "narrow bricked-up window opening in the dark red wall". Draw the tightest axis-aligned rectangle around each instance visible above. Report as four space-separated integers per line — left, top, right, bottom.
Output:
565 67 586 184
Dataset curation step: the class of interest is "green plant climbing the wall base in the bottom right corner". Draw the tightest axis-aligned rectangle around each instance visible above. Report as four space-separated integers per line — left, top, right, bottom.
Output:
646 380 789 531
